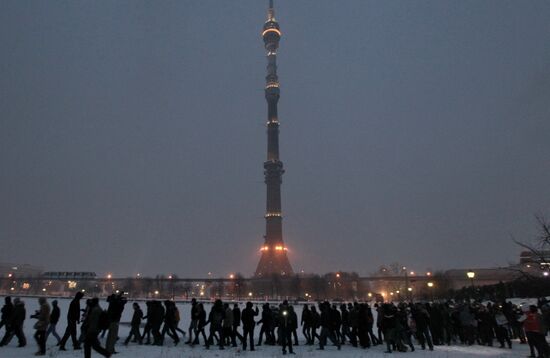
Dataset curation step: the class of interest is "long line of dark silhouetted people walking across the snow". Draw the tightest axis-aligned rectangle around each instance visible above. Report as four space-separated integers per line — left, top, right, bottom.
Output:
0 292 550 358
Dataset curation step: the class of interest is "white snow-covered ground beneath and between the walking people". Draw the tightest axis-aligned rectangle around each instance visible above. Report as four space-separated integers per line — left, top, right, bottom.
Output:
0 298 540 358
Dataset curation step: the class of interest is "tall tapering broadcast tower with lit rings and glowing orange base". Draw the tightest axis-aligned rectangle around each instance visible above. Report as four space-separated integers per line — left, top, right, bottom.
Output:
256 0 293 277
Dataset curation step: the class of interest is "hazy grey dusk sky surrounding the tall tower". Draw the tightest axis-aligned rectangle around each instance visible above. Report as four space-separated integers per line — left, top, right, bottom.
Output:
0 0 550 276
